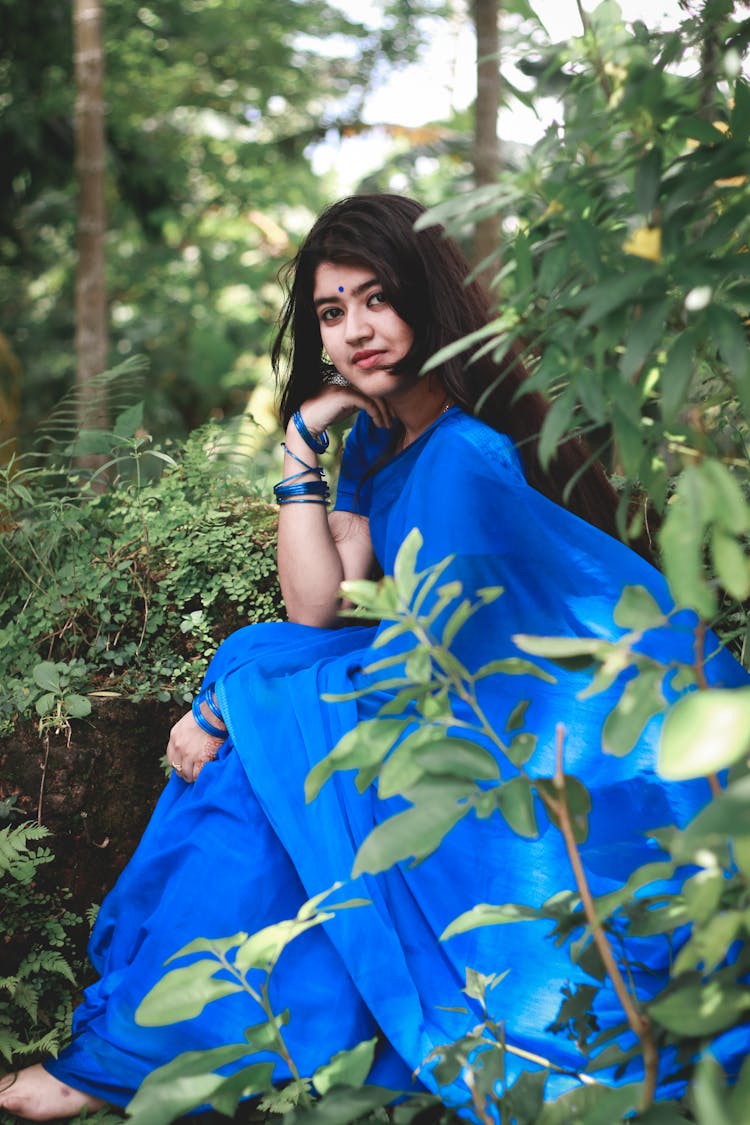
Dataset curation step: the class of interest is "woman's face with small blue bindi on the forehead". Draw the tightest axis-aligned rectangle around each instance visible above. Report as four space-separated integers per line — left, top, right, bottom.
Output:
313 262 414 398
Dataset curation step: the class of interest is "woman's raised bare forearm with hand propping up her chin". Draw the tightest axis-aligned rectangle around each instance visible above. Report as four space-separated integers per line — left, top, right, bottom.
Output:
278 387 391 628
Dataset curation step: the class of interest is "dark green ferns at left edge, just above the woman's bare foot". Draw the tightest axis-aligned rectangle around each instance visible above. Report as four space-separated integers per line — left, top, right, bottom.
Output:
0 808 81 1064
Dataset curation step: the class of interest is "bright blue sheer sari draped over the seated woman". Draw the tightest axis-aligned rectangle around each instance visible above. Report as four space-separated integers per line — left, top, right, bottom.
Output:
47 408 748 1105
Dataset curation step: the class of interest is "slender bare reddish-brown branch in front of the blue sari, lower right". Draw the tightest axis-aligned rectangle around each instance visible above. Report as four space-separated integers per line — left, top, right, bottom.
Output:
537 723 659 1112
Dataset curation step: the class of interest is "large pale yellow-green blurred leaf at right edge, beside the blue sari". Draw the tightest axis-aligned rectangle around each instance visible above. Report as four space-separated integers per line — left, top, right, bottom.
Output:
657 687 750 781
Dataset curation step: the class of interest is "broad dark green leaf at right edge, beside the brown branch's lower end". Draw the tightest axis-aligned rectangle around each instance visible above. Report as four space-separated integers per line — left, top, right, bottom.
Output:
648 978 750 1038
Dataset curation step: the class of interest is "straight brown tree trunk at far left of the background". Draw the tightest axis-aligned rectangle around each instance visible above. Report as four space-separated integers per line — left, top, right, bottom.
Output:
73 0 107 467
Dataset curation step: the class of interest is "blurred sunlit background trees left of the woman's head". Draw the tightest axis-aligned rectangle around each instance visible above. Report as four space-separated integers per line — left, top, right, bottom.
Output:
0 0 463 448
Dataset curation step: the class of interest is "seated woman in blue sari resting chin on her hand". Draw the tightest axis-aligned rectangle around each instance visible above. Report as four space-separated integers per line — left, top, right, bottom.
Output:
0 195 741 1119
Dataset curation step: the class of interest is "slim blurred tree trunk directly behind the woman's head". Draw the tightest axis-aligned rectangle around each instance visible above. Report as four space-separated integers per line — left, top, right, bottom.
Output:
472 0 500 284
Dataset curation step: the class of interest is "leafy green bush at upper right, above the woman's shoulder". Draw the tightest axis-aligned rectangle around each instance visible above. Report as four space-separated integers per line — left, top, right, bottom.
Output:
425 0 750 636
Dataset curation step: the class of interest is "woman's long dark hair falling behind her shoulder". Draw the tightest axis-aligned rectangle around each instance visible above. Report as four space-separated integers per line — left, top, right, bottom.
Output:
271 194 617 537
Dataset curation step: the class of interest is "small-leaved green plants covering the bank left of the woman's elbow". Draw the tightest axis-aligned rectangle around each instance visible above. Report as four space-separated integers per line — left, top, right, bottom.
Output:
0 412 280 729
